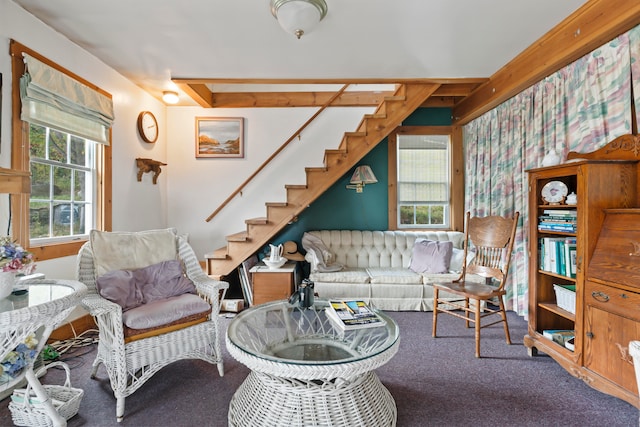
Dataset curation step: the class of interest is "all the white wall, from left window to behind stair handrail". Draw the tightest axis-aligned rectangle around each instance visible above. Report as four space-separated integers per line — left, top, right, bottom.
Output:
0 0 373 278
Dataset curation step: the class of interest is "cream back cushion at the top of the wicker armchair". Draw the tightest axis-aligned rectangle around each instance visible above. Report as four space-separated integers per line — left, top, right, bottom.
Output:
89 228 178 277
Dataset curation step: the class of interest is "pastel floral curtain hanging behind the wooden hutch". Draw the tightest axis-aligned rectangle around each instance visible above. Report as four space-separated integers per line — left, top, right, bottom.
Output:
464 26 640 315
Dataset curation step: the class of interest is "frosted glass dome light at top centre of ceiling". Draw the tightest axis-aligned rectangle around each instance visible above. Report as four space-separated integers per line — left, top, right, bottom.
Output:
271 0 328 38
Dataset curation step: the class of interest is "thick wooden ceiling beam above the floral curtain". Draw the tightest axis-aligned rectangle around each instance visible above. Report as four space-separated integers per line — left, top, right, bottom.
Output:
453 0 640 125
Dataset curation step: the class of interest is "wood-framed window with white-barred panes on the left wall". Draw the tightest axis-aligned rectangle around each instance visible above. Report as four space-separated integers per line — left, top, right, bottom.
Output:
11 40 112 260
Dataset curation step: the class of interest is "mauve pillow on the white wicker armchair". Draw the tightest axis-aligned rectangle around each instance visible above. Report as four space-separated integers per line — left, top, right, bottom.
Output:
96 260 196 311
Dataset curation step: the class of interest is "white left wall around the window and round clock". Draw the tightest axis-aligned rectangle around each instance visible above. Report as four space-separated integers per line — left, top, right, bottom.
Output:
0 0 168 278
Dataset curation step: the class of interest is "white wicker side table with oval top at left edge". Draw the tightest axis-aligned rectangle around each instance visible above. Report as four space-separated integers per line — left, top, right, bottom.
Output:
0 279 87 426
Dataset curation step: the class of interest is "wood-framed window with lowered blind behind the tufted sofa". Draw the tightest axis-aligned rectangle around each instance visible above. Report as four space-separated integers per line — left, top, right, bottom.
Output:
389 127 464 230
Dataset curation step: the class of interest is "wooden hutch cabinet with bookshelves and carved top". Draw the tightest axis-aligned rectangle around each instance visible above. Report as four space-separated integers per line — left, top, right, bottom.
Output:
524 135 640 406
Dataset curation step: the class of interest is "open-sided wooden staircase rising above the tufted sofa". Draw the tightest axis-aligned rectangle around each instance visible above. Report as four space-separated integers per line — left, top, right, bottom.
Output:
205 83 439 277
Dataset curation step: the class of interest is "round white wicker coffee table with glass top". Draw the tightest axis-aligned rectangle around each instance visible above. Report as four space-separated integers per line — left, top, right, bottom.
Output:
226 301 399 427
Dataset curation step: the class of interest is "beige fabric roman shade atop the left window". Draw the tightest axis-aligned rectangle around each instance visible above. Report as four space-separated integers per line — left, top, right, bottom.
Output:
20 54 114 145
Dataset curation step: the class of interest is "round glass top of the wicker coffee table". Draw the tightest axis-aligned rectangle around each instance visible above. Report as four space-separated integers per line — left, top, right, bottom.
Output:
227 300 399 365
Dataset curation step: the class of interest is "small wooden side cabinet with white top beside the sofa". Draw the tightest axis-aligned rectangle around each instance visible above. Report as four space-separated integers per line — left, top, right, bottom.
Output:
249 261 298 305
